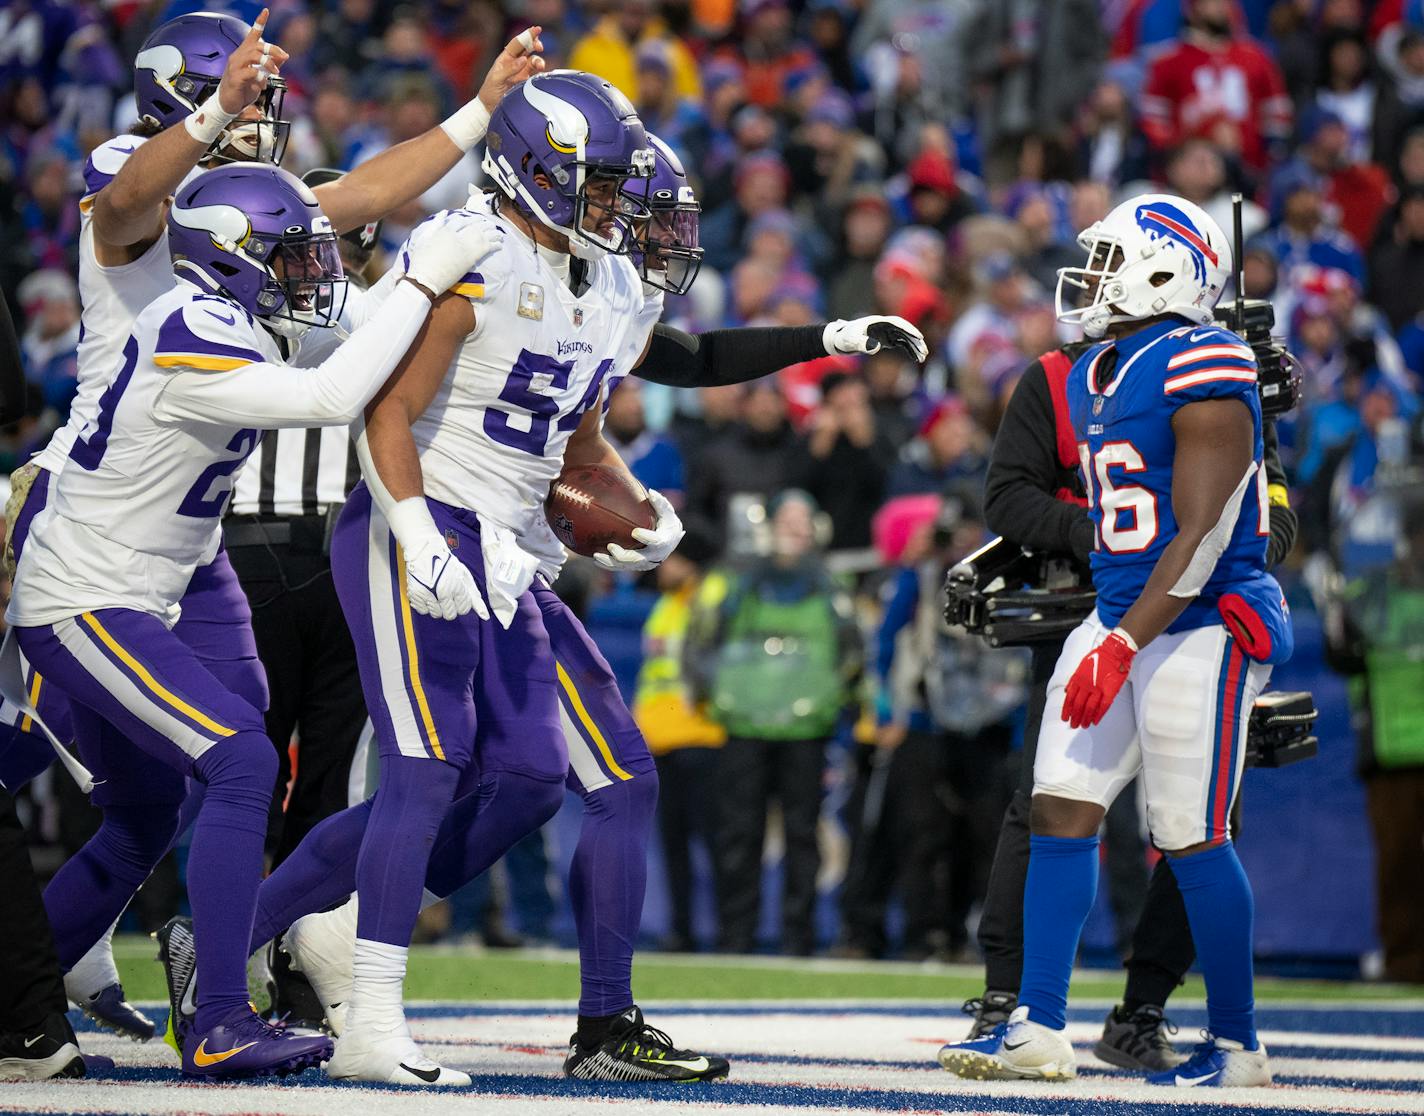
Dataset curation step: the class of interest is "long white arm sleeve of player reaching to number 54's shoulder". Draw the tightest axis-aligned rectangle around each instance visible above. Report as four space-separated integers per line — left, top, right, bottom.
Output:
157 283 430 430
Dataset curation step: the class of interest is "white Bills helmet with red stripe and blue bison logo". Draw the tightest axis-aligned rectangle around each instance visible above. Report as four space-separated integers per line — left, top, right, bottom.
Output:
1055 194 1232 337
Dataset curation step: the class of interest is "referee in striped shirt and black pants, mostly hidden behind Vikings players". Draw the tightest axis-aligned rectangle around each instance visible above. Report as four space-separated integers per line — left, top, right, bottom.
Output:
222 168 380 867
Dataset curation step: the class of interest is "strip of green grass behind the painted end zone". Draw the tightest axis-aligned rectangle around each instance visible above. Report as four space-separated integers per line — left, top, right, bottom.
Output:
105 937 1420 1008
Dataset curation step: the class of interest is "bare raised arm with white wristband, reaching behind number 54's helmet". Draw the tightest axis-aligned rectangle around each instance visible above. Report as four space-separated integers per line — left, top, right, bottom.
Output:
316 27 544 232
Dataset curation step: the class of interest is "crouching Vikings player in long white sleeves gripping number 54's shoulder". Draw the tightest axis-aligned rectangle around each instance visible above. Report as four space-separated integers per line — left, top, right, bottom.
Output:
7 164 500 1076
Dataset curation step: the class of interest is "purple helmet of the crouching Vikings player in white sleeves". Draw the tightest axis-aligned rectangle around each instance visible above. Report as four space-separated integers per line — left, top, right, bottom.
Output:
168 162 346 337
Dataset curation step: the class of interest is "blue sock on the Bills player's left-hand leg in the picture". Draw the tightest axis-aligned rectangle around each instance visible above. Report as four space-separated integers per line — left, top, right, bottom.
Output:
1018 836 1098 1031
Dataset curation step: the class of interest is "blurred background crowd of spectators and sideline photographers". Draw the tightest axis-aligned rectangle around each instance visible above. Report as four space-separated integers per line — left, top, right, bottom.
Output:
0 0 1424 955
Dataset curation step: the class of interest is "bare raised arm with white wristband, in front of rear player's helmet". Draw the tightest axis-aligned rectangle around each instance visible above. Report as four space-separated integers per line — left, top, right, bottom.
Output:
93 9 288 257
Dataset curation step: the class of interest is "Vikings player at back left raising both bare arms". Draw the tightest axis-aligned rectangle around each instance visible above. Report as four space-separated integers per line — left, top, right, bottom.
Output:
4 10 543 1039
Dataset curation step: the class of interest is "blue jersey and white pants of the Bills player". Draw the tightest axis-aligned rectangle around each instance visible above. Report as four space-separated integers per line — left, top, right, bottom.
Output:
1034 319 1290 848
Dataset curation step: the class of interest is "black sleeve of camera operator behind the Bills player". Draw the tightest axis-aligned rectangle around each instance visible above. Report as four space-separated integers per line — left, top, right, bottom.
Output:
984 360 1092 559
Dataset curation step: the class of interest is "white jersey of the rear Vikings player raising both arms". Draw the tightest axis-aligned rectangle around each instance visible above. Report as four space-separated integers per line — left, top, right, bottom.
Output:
34 135 201 473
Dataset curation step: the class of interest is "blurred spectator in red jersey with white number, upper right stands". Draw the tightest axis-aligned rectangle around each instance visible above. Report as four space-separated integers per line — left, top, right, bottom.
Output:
1142 0 1290 171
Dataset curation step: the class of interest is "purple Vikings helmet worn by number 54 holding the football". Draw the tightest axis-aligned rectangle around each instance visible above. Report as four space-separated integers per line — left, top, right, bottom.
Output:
484 70 652 259
